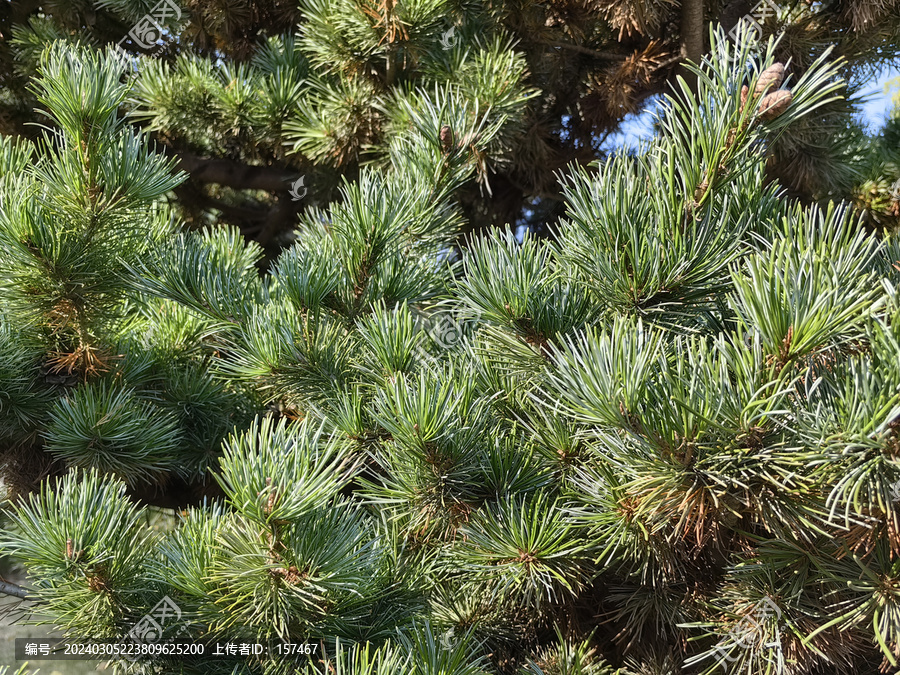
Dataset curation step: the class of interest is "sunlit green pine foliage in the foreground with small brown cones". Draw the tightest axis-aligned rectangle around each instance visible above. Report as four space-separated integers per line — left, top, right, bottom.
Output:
0 22 900 675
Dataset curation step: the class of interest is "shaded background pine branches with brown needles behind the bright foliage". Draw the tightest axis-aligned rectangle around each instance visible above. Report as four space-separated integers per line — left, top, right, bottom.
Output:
0 0 900 242
